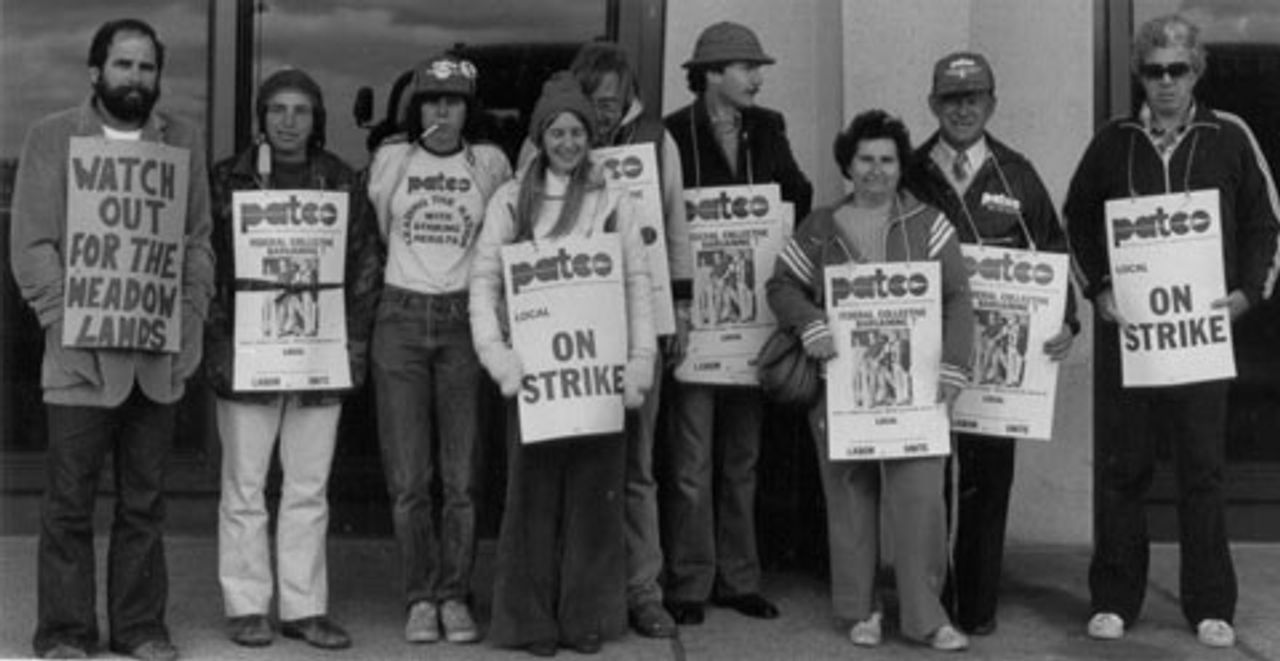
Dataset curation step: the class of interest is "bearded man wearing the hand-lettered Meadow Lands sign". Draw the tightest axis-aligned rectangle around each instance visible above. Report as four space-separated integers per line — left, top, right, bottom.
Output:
9 19 214 661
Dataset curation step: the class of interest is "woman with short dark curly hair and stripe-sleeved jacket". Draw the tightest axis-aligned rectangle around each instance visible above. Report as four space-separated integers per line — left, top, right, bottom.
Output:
768 110 973 651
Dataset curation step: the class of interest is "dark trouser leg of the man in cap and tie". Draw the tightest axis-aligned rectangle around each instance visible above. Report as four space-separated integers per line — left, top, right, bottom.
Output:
942 434 1016 630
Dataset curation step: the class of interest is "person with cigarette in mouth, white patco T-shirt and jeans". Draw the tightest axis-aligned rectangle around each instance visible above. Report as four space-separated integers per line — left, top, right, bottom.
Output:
369 53 511 643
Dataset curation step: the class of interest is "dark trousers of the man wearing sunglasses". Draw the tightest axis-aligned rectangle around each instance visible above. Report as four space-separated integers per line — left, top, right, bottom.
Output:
1089 342 1236 626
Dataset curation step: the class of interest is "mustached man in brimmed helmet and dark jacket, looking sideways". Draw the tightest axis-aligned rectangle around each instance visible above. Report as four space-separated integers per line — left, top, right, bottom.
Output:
663 22 813 624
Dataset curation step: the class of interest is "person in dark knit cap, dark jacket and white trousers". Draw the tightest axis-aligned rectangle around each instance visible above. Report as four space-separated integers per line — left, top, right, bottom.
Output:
205 68 379 649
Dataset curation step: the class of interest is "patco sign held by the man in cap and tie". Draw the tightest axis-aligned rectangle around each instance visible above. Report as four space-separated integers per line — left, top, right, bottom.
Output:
951 245 1069 441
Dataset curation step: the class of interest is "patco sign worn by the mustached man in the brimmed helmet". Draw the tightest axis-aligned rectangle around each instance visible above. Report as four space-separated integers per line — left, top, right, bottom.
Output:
676 183 794 386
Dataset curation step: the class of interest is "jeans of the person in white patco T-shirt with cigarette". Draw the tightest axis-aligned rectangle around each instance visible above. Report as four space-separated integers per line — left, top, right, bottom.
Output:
372 286 484 605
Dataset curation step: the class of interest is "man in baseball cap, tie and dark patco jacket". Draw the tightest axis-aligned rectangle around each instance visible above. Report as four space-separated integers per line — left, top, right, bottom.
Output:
908 53 1080 635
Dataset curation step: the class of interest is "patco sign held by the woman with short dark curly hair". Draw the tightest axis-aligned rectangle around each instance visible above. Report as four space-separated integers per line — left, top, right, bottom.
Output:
823 261 951 460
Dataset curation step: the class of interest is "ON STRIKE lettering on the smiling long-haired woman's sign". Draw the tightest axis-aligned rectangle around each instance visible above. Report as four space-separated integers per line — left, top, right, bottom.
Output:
520 331 623 404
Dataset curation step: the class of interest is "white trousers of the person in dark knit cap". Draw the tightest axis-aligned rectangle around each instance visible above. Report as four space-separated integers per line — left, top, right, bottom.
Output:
218 396 342 620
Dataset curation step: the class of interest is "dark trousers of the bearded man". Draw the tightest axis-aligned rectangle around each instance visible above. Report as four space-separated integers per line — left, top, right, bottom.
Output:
33 389 175 656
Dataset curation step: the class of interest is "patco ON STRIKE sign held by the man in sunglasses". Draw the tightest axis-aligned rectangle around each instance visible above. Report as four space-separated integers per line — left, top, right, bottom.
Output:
1106 191 1235 387
